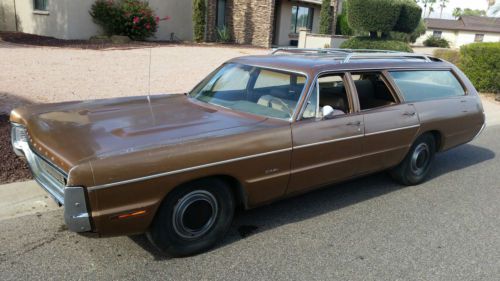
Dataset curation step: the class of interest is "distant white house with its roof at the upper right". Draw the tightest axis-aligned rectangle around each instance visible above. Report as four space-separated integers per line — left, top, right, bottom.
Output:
416 16 500 48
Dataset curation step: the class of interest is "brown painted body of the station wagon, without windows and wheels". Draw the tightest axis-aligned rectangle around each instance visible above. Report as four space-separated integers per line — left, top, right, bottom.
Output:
11 55 485 235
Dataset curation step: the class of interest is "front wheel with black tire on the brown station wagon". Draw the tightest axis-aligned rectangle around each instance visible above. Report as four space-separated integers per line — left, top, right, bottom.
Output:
147 179 235 257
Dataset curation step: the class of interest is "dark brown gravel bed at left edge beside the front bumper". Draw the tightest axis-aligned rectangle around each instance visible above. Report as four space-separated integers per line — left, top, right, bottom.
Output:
0 115 32 184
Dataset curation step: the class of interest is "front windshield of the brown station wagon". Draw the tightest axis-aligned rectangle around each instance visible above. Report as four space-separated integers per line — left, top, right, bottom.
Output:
189 63 306 119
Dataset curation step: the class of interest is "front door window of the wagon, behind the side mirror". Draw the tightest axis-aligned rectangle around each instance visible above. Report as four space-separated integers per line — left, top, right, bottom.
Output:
303 74 352 118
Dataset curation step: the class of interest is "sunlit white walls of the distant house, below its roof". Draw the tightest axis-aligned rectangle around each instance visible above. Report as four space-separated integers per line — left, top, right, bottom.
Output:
415 29 500 48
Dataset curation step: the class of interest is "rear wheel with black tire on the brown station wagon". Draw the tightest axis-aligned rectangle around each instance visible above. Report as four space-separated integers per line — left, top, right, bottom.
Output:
390 133 436 185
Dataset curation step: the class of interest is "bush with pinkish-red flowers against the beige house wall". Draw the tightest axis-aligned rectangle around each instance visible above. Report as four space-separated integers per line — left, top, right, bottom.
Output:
90 0 169 40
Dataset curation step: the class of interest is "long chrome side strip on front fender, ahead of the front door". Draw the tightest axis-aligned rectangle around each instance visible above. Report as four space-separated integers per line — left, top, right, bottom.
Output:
87 148 292 191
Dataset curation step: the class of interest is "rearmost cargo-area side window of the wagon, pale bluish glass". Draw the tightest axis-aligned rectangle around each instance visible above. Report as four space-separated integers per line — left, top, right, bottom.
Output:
390 70 465 102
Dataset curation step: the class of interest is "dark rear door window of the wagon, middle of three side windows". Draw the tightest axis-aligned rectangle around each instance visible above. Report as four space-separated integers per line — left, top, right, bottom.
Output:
352 72 396 110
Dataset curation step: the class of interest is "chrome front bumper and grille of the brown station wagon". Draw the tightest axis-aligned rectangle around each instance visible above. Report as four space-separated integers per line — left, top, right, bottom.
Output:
11 124 92 232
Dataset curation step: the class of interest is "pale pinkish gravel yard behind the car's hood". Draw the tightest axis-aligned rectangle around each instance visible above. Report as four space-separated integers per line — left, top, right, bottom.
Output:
0 41 268 113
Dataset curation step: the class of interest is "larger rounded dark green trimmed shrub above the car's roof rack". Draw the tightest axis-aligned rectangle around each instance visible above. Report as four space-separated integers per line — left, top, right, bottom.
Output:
347 0 401 33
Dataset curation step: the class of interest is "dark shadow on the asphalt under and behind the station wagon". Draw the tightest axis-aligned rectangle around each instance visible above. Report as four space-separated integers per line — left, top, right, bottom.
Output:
130 144 495 260
